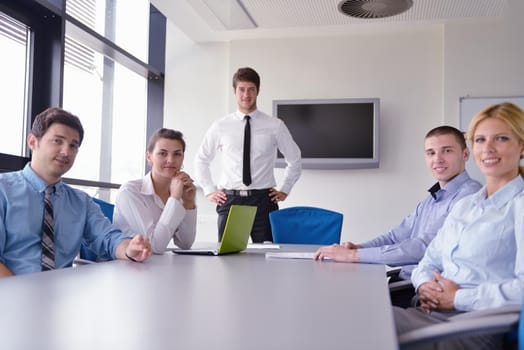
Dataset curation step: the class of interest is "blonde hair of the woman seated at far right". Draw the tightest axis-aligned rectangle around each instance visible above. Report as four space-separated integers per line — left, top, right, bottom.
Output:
466 102 524 178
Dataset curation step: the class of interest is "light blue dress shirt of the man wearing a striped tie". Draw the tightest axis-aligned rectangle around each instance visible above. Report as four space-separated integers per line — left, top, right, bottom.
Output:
0 164 129 275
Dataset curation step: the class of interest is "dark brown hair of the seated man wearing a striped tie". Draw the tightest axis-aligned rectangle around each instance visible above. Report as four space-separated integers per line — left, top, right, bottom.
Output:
31 107 84 146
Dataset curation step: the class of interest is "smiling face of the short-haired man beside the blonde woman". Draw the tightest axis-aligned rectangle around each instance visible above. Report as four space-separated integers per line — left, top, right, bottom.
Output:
424 134 469 187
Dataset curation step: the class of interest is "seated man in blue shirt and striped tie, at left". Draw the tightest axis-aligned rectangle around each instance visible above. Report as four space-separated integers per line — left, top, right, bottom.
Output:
0 108 151 277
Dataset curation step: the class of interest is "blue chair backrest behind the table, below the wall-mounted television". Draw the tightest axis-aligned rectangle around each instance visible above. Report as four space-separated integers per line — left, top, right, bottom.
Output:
269 207 344 245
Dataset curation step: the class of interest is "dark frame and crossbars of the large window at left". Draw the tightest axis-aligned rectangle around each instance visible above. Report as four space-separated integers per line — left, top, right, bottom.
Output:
0 0 166 189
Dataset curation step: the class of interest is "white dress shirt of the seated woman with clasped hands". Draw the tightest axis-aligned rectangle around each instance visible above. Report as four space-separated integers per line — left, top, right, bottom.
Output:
113 173 197 254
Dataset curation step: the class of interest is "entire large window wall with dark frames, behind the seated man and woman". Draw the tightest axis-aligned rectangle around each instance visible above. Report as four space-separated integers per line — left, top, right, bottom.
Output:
0 0 165 200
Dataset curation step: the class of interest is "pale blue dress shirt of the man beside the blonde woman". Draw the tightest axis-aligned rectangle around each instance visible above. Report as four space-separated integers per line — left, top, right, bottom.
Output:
358 171 482 279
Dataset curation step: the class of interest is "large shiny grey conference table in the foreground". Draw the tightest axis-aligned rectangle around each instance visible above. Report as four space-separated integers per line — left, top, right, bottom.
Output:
0 245 398 350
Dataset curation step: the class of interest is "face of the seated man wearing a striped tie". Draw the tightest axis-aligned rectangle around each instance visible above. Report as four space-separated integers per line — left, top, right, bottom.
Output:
27 123 80 184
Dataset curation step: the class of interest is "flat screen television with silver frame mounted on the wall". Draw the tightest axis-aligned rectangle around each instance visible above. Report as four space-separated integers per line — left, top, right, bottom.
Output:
273 98 380 169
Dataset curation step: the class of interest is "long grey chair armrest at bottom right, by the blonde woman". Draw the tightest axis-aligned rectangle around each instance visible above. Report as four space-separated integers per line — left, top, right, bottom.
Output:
398 311 520 349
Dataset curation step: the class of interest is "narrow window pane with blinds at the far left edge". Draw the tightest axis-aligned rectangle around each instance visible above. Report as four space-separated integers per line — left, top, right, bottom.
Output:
0 12 30 156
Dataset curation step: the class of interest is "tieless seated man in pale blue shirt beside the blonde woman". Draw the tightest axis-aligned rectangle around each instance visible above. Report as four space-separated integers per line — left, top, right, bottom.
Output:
315 126 481 279
